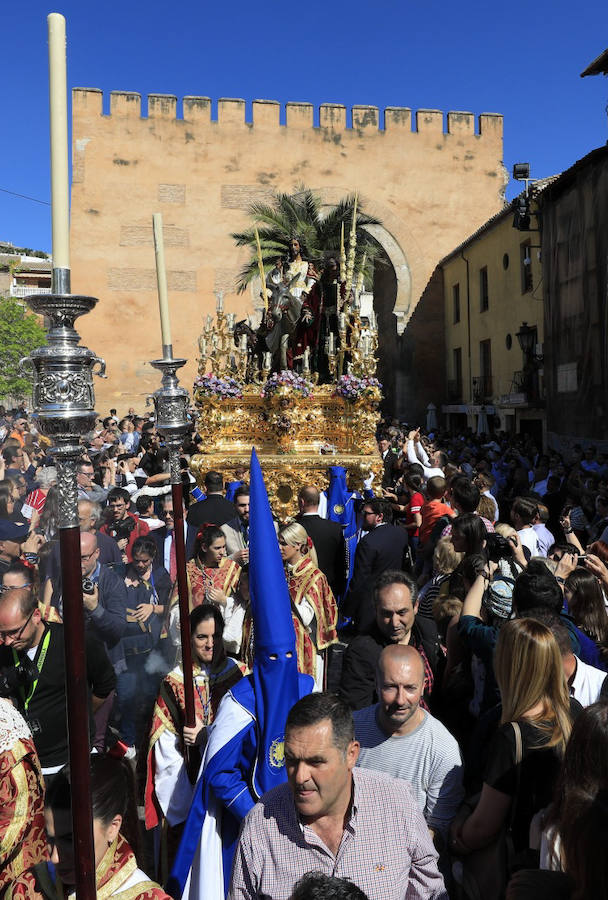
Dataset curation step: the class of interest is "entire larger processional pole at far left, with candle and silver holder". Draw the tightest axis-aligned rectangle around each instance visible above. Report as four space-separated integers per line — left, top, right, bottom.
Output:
22 13 105 900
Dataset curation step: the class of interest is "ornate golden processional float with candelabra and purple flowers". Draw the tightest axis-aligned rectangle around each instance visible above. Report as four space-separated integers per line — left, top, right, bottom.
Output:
191 198 382 521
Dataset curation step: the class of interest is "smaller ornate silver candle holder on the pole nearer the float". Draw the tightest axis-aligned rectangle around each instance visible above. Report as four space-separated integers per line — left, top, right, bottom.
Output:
150 357 190 484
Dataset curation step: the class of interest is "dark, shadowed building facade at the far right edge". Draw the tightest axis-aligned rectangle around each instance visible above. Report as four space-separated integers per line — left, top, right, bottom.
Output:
539 147 608 452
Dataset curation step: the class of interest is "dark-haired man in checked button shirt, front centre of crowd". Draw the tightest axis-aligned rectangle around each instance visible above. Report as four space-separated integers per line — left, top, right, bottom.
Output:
228 693 448 900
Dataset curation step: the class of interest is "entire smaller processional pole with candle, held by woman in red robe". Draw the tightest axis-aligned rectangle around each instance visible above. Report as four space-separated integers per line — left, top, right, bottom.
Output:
150 213 197 779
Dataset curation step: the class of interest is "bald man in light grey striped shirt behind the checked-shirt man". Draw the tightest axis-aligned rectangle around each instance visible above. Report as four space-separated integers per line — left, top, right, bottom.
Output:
353 644 464 851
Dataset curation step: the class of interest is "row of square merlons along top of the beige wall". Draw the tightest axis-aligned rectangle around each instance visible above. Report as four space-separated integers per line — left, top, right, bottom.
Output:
72 87 503 142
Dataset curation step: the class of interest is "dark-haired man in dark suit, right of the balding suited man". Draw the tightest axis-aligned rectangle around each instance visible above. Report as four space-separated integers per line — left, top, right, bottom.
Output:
343 499 407 634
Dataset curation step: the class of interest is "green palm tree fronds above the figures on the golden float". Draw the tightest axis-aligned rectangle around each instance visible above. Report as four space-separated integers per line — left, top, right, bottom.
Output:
232 187 380 293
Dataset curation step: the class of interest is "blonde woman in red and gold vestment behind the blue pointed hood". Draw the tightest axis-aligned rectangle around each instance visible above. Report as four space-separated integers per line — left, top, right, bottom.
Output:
279 522 338 690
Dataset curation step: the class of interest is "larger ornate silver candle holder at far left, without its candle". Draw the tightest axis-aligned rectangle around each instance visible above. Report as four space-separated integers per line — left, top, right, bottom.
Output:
21 294 106 528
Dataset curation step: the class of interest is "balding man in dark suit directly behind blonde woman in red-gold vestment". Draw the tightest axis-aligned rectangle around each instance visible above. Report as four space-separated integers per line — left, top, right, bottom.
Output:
296 484 346 599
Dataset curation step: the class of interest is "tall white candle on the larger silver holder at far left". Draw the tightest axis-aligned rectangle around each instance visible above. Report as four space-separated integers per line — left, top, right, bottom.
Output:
46 13 70 269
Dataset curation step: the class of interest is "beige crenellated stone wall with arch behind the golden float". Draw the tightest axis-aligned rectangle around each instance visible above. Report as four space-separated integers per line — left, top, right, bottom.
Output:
71 88 505 412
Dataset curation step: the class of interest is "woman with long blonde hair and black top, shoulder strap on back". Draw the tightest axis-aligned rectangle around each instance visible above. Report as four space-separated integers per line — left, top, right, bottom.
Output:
450 619 571 856
